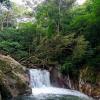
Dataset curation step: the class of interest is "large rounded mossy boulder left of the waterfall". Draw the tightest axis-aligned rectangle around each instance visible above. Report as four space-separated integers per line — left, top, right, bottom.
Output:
0 55 30 99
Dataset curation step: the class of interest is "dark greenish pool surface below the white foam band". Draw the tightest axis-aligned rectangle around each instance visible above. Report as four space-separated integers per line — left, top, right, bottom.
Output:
12 95 92 100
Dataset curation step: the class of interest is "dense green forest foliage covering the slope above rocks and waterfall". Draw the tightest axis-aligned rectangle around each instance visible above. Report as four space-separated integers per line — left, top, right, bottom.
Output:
0 0 100 83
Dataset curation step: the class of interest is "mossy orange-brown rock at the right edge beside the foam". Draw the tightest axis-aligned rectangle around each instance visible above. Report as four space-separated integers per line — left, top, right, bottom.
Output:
79 67 100 100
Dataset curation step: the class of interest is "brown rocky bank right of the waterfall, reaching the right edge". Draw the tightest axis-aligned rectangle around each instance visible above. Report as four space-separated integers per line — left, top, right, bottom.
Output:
50 67 100 100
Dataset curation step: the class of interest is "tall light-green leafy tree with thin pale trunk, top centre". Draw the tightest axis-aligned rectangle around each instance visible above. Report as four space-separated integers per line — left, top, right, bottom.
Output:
36 0 74 36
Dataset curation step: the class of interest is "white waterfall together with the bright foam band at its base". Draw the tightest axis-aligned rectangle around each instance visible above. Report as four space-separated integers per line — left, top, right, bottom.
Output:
30 69 92 100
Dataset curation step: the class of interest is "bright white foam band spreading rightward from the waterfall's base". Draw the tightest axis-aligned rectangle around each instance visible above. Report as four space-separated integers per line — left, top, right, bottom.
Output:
32 87 88 98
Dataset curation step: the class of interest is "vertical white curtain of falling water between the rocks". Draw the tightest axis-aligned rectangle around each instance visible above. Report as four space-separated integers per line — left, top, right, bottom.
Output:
30 69 50 88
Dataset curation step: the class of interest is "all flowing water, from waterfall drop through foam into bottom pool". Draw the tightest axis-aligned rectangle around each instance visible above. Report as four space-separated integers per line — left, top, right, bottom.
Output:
25 69 92 100
